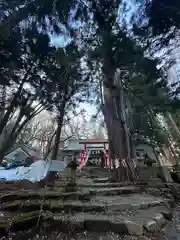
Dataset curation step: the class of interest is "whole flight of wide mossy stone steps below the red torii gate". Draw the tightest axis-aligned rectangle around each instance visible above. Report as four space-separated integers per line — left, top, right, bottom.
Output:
0 169 173 236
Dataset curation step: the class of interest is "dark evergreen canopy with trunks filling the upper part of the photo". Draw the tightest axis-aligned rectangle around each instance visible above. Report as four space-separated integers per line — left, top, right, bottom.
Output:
0 0 179 176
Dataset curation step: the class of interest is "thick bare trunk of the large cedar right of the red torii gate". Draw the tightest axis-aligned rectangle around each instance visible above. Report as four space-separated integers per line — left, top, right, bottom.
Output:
103 79 134 180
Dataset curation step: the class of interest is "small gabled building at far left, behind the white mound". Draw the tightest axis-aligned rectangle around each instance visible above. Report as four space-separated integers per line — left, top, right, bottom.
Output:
3 144 41 165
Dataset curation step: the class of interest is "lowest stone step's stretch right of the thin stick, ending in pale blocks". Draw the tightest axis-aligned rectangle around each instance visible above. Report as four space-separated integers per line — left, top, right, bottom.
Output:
44 204 172 236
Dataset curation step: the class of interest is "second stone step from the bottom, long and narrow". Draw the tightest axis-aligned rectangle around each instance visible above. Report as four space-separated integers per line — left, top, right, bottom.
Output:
0 194 171 212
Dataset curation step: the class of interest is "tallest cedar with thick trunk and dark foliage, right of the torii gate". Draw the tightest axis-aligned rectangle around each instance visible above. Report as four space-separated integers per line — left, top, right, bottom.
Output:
75 0 177 180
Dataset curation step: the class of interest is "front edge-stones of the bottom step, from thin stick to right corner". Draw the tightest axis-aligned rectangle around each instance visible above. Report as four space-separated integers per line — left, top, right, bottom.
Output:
44 204 172 236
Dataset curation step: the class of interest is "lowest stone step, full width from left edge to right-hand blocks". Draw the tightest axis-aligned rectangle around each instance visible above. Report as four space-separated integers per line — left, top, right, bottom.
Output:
0 207 172 239
